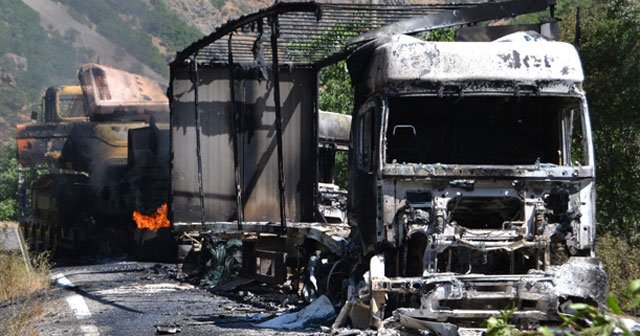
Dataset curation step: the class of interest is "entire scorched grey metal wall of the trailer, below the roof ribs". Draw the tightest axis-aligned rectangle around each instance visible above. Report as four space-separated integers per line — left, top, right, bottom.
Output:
171 66 317 223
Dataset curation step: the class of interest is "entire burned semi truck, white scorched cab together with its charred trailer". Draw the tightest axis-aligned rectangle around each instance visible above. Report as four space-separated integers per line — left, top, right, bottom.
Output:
169 0 607 335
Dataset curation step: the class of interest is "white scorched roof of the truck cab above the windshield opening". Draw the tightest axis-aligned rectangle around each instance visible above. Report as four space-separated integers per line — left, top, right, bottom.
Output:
348 32 584 98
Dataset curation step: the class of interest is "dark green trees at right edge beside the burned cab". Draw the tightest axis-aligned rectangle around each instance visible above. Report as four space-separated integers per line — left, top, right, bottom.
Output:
579 0 640 246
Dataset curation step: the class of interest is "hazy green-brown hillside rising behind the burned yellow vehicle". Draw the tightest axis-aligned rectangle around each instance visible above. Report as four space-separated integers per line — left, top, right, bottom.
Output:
0 0 271 144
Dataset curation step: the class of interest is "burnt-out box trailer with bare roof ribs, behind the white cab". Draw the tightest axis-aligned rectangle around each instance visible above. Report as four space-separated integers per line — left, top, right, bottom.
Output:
169 2 500 292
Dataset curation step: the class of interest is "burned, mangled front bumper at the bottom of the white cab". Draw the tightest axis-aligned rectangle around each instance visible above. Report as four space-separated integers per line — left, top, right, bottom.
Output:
371 257 607 334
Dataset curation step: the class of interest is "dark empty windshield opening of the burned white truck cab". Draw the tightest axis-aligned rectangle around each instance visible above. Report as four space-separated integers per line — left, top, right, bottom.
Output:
386 96 582 165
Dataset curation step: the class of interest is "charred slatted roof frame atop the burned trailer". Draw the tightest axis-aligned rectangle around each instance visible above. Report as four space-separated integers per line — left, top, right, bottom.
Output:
171 0 555 68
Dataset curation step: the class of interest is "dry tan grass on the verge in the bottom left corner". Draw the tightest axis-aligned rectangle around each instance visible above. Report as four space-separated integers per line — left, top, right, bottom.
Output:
0 254 51 336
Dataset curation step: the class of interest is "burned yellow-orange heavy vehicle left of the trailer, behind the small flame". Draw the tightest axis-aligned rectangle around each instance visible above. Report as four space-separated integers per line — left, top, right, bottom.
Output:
17 64 170 255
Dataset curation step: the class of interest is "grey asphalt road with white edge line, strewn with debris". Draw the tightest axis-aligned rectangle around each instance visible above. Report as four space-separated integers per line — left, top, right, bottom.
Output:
38 261 320 336
